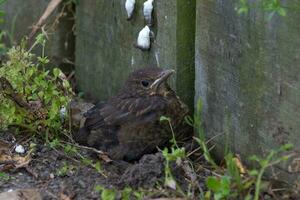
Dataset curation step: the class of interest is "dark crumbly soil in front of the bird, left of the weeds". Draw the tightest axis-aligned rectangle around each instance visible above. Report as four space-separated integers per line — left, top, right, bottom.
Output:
0 133 204 200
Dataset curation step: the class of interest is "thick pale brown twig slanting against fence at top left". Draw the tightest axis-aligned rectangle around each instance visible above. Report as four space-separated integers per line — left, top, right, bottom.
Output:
29 0 62 40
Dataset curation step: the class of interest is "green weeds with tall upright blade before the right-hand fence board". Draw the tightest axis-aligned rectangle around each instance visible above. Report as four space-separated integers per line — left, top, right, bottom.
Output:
191 101 292 200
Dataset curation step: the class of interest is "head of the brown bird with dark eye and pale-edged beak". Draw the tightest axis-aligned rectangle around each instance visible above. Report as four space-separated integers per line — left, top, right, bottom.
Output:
125 67 175 96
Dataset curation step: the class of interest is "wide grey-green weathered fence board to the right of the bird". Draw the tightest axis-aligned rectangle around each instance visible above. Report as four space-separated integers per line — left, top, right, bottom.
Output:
195 0 300 186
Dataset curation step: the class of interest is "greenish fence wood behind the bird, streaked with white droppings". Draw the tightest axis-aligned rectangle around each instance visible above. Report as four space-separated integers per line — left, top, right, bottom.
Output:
76 0 195 109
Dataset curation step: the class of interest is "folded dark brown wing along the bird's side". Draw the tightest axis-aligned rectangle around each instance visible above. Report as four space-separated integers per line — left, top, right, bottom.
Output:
85 97 166 130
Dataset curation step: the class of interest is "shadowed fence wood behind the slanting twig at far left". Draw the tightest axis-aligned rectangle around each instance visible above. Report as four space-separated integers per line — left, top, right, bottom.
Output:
1 0 74 71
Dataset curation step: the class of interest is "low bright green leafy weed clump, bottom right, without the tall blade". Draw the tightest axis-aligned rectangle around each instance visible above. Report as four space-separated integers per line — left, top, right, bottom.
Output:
206 144 292 200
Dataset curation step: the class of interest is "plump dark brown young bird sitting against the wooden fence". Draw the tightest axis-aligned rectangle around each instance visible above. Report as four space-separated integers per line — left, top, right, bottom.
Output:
74 68 192 161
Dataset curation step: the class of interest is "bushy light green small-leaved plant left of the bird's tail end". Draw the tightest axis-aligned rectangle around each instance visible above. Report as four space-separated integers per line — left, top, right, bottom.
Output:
0 36 72 133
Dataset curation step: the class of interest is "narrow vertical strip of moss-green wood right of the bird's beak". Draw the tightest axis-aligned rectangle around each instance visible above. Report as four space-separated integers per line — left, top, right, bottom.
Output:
176 0 196 109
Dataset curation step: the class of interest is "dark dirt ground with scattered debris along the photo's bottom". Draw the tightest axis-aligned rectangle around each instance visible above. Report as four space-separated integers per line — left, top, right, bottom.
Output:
0 132 297 200
